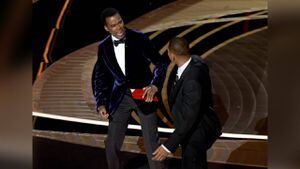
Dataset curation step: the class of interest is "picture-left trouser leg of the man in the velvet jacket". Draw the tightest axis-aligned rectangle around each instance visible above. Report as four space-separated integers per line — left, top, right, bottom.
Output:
105 95 132 169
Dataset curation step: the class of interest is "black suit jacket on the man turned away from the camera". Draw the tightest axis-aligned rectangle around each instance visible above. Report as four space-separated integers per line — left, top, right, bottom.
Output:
164 56 221 152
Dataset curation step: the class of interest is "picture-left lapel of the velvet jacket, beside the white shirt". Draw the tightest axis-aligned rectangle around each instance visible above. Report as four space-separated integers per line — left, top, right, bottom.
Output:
105 37 126 77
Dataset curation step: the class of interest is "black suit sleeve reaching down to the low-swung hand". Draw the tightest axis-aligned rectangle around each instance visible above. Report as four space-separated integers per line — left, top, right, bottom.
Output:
164 80 202 152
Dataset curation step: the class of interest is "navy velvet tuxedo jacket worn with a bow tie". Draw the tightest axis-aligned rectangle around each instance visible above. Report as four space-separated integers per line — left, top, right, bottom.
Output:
92 28 168 114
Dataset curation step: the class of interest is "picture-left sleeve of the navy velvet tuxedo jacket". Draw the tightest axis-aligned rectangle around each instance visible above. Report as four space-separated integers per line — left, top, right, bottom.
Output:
93 49 113 111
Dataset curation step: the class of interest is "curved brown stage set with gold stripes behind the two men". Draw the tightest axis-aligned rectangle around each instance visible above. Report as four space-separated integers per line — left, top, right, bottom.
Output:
33 0 268 167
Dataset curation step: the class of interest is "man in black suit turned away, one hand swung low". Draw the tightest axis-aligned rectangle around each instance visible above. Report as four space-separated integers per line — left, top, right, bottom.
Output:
153 37 221 169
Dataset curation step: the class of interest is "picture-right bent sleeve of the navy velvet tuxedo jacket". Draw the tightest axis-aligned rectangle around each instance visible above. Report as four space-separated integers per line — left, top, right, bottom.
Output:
142 34 169 91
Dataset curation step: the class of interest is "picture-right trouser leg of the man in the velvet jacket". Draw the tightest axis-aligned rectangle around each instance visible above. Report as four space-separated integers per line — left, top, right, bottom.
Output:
138 110 164 169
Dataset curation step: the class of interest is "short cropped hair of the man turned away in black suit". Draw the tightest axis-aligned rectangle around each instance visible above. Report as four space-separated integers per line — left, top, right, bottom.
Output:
168 37 190 55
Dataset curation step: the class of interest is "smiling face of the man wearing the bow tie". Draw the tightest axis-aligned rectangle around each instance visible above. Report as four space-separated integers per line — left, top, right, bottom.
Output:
104 13 125 39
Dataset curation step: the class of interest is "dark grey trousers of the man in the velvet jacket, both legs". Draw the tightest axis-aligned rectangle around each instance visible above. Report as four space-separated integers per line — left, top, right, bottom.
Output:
105 92 163 169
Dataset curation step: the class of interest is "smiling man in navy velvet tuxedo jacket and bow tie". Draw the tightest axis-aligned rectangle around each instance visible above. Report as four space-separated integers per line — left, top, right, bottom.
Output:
93 8 167 169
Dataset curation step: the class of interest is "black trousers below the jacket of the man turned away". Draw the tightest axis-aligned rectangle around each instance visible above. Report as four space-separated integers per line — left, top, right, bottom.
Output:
181 144 207 169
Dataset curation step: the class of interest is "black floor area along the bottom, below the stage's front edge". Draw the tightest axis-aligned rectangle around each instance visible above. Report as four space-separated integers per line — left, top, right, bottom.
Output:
33 137 264 169
